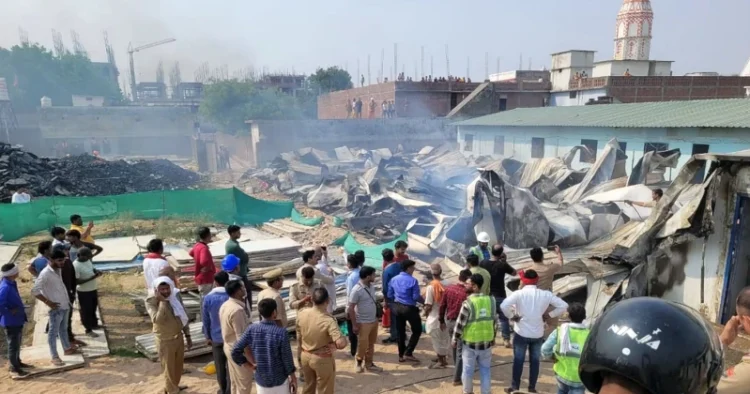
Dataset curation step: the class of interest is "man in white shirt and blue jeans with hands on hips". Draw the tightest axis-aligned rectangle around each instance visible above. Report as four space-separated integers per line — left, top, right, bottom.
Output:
500 269 568 393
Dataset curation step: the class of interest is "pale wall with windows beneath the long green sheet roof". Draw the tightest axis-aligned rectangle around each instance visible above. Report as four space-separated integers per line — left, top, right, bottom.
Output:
457 126 750 180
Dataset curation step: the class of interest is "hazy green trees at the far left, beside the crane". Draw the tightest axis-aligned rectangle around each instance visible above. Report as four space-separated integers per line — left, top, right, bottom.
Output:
0 44 122 111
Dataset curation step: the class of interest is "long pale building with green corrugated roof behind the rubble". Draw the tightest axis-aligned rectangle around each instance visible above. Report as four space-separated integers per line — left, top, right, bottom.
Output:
456 99 750 185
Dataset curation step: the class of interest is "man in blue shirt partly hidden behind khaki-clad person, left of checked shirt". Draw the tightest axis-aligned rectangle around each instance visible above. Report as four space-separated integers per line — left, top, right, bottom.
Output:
201 271 231 394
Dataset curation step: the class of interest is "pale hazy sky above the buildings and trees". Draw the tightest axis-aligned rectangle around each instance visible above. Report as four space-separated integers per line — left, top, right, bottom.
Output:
0 0 750 89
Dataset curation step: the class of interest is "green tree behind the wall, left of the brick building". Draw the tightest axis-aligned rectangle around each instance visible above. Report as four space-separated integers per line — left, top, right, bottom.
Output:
200 79 303 134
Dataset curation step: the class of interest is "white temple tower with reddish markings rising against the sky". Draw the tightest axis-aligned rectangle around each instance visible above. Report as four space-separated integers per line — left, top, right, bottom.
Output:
614 0 654 60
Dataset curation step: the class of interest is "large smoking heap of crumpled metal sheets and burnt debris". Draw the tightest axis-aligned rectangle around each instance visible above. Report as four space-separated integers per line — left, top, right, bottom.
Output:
241 140 679 252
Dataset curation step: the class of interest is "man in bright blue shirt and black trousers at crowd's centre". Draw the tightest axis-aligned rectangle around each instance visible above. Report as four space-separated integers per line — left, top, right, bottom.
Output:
387 260 424 363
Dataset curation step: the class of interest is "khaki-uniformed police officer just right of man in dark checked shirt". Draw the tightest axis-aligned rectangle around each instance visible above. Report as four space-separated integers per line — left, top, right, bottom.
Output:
297 287 346 394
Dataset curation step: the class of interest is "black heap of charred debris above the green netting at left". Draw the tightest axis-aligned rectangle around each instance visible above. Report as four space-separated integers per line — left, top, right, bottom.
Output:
0 143 200 198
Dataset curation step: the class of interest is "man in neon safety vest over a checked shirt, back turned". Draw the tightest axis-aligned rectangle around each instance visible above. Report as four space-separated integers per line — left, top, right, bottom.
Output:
453 274 497 394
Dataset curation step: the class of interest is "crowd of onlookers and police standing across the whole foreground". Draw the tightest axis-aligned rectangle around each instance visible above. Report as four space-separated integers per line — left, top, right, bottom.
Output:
0 220 750 394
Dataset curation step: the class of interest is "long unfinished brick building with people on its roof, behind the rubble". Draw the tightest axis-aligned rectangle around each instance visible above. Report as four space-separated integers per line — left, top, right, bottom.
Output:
318 80 550 119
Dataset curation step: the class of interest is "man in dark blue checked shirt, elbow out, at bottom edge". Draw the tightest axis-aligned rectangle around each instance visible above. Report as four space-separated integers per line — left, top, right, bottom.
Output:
232 298 297 393
